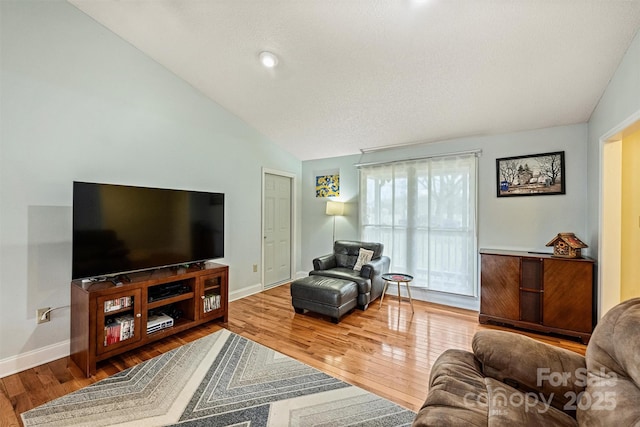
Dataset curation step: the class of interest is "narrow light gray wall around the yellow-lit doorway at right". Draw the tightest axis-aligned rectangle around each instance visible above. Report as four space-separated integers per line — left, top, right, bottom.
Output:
587 32 640 257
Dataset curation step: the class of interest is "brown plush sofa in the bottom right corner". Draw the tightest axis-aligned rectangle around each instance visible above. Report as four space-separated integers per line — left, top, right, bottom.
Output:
413 298 640 427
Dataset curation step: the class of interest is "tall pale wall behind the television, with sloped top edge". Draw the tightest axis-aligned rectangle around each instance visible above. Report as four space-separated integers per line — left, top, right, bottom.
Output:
0 1 301 377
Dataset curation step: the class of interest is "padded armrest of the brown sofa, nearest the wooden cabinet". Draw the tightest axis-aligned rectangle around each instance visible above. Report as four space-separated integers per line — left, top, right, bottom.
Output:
471 330 587 412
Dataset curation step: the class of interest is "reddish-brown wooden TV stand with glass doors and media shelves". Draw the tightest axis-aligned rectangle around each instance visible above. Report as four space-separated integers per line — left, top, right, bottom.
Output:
71 264 229 377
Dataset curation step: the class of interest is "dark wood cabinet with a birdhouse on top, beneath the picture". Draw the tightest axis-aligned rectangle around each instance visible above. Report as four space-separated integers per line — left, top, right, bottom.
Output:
479 249 596 344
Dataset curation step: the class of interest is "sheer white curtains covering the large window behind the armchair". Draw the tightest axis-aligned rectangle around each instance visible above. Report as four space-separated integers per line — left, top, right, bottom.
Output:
360 154 477 296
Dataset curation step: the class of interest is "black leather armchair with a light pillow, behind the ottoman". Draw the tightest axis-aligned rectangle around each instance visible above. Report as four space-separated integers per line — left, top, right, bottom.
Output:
309 240 391 310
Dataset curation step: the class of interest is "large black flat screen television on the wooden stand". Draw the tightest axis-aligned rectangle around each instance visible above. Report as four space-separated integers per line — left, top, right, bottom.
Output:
71 182 224 279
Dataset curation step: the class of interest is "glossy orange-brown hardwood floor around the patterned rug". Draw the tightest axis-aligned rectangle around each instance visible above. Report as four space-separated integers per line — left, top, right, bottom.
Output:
0 285 586 426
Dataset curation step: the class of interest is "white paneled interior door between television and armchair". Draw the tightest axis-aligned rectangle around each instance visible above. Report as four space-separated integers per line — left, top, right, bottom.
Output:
263 173 291 288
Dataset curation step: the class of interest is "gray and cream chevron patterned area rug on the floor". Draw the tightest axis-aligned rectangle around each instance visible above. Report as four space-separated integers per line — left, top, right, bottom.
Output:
22 329 415 427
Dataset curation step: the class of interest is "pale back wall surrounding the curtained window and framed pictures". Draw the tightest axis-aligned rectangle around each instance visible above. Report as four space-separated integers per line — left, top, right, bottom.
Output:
301 124 589 288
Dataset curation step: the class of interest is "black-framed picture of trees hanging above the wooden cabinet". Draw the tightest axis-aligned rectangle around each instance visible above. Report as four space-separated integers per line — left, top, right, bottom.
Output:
496 151 566 197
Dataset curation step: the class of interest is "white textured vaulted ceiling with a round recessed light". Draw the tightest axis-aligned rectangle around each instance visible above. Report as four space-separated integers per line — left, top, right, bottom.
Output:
69 0 640 160
